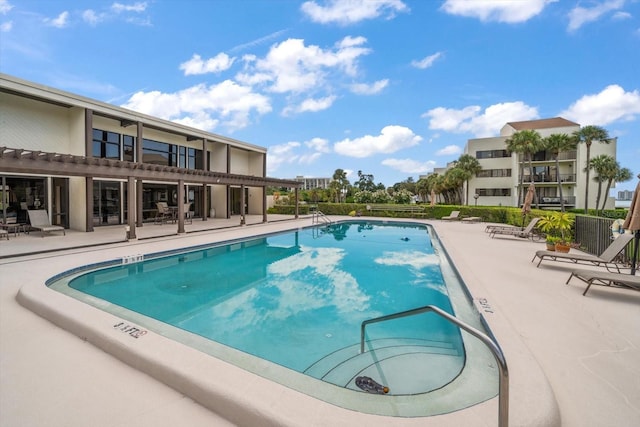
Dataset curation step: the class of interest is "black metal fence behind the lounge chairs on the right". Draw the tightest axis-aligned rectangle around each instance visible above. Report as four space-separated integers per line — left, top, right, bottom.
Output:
574 215 633 264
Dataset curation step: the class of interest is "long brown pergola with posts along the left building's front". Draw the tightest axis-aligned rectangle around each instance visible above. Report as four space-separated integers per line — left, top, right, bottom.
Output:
0 147 302 238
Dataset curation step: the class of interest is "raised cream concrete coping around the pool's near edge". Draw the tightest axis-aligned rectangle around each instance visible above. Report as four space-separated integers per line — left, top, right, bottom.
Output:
16 219 560 426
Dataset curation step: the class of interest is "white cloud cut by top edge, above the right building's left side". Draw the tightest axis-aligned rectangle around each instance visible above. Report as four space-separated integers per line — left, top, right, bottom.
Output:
440 0 558 24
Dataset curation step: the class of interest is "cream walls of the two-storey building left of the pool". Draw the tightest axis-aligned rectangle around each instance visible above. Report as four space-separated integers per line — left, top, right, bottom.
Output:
0 74 282 230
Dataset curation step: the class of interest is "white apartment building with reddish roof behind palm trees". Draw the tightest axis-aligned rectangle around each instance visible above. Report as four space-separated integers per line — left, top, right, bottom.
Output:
464 117 617 209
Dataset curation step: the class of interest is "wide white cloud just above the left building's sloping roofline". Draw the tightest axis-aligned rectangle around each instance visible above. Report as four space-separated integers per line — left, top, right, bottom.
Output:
123 80 271 131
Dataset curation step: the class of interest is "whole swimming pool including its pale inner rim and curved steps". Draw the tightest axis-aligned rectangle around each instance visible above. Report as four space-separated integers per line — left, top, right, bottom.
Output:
51 221 497 416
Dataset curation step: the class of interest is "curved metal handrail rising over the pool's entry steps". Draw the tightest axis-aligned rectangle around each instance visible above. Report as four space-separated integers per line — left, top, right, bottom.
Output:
360 305 509 427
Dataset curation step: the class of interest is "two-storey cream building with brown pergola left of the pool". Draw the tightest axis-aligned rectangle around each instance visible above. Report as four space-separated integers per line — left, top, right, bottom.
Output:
0 74 300 237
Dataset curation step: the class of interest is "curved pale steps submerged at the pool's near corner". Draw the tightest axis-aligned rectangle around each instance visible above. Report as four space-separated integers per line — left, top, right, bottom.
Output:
305 339 464 395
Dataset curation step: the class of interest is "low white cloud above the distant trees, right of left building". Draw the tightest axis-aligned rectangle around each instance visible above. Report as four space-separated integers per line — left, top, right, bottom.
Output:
333 126 422 157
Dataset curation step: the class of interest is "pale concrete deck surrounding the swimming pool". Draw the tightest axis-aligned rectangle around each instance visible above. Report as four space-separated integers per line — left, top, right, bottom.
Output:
0 216 640 427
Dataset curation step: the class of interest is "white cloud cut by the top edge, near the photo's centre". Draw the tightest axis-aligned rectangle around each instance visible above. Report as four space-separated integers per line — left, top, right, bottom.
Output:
300 0 409 25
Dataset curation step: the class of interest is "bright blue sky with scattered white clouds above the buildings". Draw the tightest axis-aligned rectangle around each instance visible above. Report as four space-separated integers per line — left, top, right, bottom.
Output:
0 0 640 195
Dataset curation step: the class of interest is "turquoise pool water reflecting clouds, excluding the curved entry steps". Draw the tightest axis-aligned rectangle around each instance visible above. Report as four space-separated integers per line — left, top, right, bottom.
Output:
69 223 462 372
